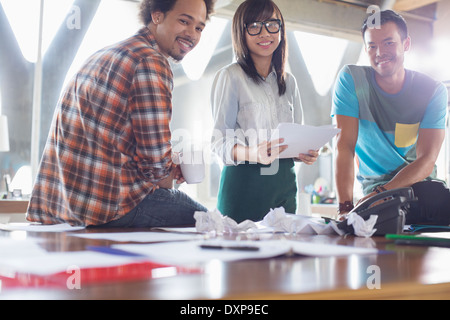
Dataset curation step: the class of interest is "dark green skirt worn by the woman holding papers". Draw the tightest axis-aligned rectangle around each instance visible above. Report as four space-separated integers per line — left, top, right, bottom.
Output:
217 159 297 223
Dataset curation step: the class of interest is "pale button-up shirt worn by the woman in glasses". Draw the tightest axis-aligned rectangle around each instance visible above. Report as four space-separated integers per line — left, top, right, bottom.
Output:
211 63 303 165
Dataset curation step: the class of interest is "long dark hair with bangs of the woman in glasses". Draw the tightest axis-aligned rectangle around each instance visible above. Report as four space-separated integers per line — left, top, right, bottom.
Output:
232 0 287 96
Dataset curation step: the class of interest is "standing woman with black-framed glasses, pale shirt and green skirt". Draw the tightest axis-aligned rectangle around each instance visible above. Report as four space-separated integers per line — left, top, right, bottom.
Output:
211 0 318 222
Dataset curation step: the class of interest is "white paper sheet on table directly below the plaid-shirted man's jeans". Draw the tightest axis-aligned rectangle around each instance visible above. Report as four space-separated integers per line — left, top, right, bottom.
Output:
69 232 203 242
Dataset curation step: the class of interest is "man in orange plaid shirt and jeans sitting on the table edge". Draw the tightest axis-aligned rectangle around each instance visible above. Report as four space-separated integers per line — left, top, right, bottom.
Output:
27 0 213 227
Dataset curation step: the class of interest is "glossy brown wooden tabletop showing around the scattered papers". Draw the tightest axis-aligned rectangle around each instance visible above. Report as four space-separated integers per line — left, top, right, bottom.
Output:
0 229 450 300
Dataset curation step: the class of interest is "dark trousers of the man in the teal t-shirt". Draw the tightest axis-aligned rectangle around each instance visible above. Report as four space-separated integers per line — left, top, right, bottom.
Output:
406 181 450 226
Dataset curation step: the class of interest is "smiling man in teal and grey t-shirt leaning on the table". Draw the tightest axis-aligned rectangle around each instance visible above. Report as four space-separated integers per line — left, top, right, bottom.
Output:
332 10 450 224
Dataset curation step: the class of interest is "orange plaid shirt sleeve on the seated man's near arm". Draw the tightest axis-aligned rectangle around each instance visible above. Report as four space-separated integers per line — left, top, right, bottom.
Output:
130 55 173 182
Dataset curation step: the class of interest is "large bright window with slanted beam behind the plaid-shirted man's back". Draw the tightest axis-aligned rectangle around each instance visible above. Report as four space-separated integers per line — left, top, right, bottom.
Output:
0 0 140 196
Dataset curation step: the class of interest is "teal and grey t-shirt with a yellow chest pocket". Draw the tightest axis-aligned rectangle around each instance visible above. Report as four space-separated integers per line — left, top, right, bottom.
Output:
331 65 448 194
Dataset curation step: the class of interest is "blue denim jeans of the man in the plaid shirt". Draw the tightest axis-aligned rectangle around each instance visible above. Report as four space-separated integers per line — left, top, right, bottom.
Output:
97 188 208 228
